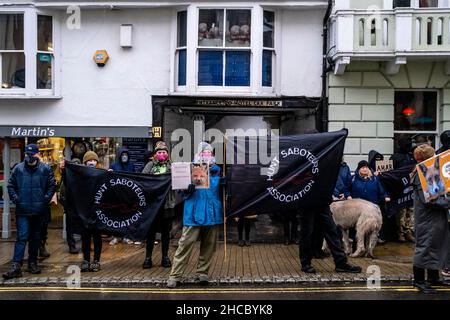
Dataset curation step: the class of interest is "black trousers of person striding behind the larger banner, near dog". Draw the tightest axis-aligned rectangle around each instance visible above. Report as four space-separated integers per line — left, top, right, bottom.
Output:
299 206 347 267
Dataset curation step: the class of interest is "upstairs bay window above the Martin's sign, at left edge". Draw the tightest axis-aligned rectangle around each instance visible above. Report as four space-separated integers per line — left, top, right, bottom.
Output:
0 8 56 98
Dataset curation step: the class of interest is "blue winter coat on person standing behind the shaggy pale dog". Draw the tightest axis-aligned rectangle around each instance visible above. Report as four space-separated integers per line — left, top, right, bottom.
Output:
351 172 388 205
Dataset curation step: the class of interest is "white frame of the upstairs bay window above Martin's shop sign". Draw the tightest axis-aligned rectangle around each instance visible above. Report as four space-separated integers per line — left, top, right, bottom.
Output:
0 7 61 99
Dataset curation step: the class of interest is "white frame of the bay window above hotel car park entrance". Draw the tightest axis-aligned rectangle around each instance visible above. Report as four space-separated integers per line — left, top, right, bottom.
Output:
170 3 281 96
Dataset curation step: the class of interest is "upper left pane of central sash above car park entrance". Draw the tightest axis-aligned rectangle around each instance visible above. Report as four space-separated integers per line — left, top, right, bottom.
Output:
198 10 223 47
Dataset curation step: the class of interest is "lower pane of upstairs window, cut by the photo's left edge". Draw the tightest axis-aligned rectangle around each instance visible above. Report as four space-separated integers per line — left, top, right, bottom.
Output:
1 53 25 89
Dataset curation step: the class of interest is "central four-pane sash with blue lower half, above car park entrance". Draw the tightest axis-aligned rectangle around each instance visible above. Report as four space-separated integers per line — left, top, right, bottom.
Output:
198 9 251 87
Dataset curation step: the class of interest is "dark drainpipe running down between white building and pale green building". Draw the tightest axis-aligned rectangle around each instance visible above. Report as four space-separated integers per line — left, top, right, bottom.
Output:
316 0 333 132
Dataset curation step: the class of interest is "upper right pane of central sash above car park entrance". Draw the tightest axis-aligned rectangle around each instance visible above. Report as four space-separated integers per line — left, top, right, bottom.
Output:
226 10 251 47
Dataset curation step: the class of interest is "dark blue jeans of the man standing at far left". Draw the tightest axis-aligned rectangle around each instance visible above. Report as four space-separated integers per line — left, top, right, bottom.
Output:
13 215 45 264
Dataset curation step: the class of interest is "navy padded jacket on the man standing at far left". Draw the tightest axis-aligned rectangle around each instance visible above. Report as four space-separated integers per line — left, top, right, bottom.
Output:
8 160 56 216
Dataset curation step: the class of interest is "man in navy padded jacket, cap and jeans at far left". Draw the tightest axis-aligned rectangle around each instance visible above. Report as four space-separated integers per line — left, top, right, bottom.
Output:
3 144 56 279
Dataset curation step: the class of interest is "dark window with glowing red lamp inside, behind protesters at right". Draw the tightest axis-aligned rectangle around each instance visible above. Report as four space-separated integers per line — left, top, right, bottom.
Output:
394 91 438 150
